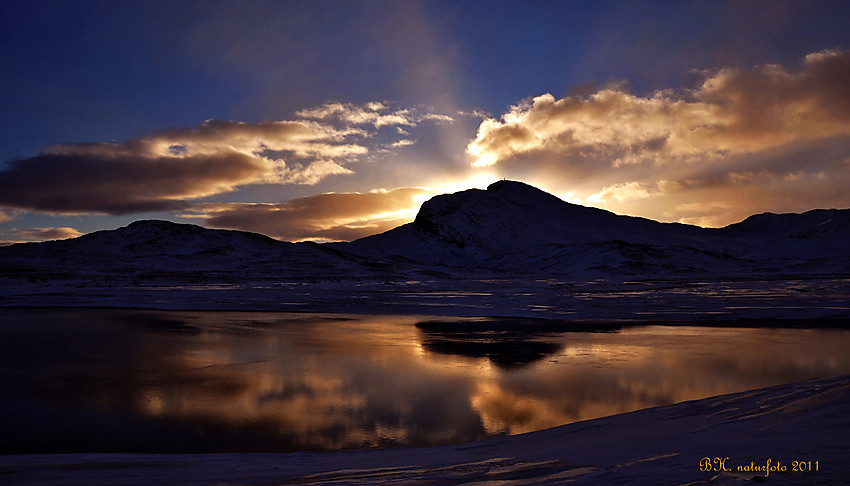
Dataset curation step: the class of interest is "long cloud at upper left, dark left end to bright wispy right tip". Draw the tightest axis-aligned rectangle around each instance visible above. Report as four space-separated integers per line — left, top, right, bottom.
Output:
0 103 450 214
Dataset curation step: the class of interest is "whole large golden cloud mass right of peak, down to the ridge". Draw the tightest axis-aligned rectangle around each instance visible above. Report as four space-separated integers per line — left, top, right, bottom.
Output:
467 50 850 224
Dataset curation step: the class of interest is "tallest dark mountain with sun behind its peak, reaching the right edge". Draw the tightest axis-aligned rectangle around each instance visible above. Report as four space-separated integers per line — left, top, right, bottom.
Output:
334 181 850 275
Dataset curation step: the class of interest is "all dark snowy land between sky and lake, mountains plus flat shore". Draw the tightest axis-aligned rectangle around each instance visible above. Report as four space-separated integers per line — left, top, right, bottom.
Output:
0 181 850 320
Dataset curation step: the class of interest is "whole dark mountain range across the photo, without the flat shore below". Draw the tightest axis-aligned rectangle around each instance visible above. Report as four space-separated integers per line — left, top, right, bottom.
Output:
0 181 850 283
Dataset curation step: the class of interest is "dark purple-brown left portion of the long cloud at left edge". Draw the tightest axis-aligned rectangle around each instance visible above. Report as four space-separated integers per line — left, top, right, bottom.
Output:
0 148 272 214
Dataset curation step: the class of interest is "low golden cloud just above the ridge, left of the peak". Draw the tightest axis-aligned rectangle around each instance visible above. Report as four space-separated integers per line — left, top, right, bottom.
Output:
193 188 429 241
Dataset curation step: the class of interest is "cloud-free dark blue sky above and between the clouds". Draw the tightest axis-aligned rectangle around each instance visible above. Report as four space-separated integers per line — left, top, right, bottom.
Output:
0 1 850 239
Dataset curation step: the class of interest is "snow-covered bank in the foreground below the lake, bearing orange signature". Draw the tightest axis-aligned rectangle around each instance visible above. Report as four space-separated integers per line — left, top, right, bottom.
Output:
0 376 850 485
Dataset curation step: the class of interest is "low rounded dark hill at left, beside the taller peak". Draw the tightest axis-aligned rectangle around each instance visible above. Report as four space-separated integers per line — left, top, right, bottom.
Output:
0 220 390 285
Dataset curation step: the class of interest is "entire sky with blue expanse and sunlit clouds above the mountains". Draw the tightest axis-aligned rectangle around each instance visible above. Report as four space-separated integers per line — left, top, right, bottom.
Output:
0 0 850 244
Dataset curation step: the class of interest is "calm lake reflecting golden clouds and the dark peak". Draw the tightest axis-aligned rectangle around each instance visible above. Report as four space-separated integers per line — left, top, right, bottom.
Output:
0 309 850 454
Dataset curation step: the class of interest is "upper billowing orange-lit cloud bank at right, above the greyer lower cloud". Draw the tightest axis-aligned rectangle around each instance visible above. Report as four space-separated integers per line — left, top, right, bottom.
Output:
467 51 850 166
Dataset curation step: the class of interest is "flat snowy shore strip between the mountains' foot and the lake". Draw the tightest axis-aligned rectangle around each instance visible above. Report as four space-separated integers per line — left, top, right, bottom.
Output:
0 273 850 327
